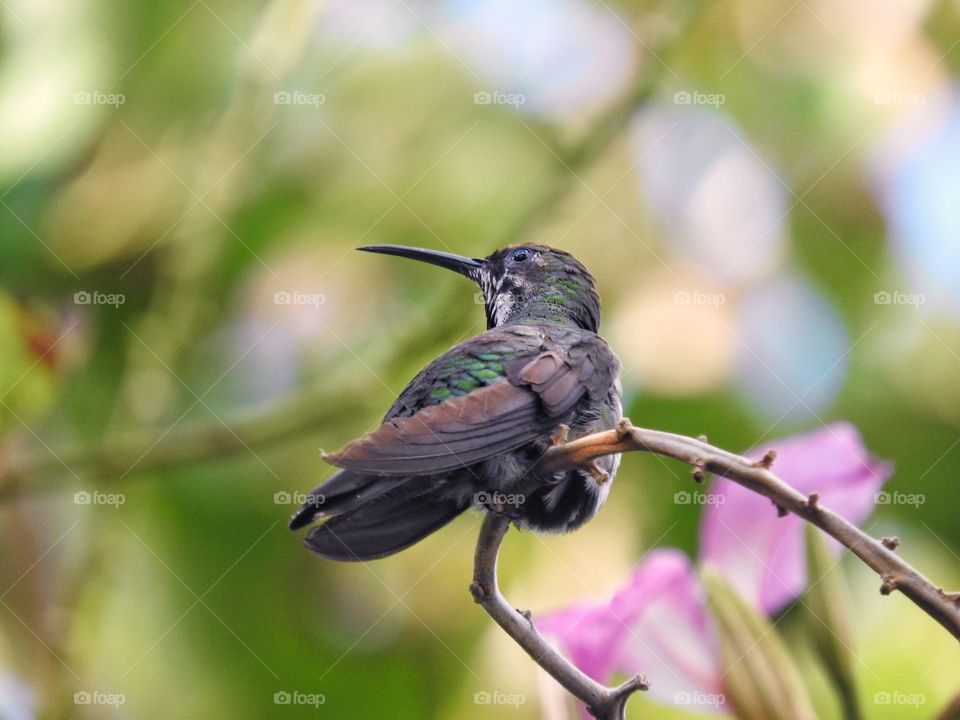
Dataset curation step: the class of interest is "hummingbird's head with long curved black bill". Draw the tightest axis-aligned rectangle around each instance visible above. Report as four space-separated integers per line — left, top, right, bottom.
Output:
360 244 600 332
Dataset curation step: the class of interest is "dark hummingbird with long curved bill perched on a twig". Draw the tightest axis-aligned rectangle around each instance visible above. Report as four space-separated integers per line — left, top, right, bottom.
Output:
290 244 622 561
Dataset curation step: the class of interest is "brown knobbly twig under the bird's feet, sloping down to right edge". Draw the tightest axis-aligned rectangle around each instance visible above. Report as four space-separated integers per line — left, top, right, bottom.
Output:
540 420 960 639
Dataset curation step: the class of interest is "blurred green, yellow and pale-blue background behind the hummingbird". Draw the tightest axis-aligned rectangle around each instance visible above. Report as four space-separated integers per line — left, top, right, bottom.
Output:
0 0 960 720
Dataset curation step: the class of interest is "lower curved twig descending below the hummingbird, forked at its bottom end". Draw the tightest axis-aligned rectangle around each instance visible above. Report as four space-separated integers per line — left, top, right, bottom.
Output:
470 512 647 720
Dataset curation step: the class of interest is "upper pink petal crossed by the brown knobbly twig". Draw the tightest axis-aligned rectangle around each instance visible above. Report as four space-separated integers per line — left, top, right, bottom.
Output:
700 422 892 614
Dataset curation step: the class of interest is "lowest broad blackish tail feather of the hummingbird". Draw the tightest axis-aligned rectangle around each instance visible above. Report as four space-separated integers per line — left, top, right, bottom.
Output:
305 478 470 560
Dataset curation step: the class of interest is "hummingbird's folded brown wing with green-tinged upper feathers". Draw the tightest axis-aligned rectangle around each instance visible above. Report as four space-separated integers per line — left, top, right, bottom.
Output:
326 326 618 475
